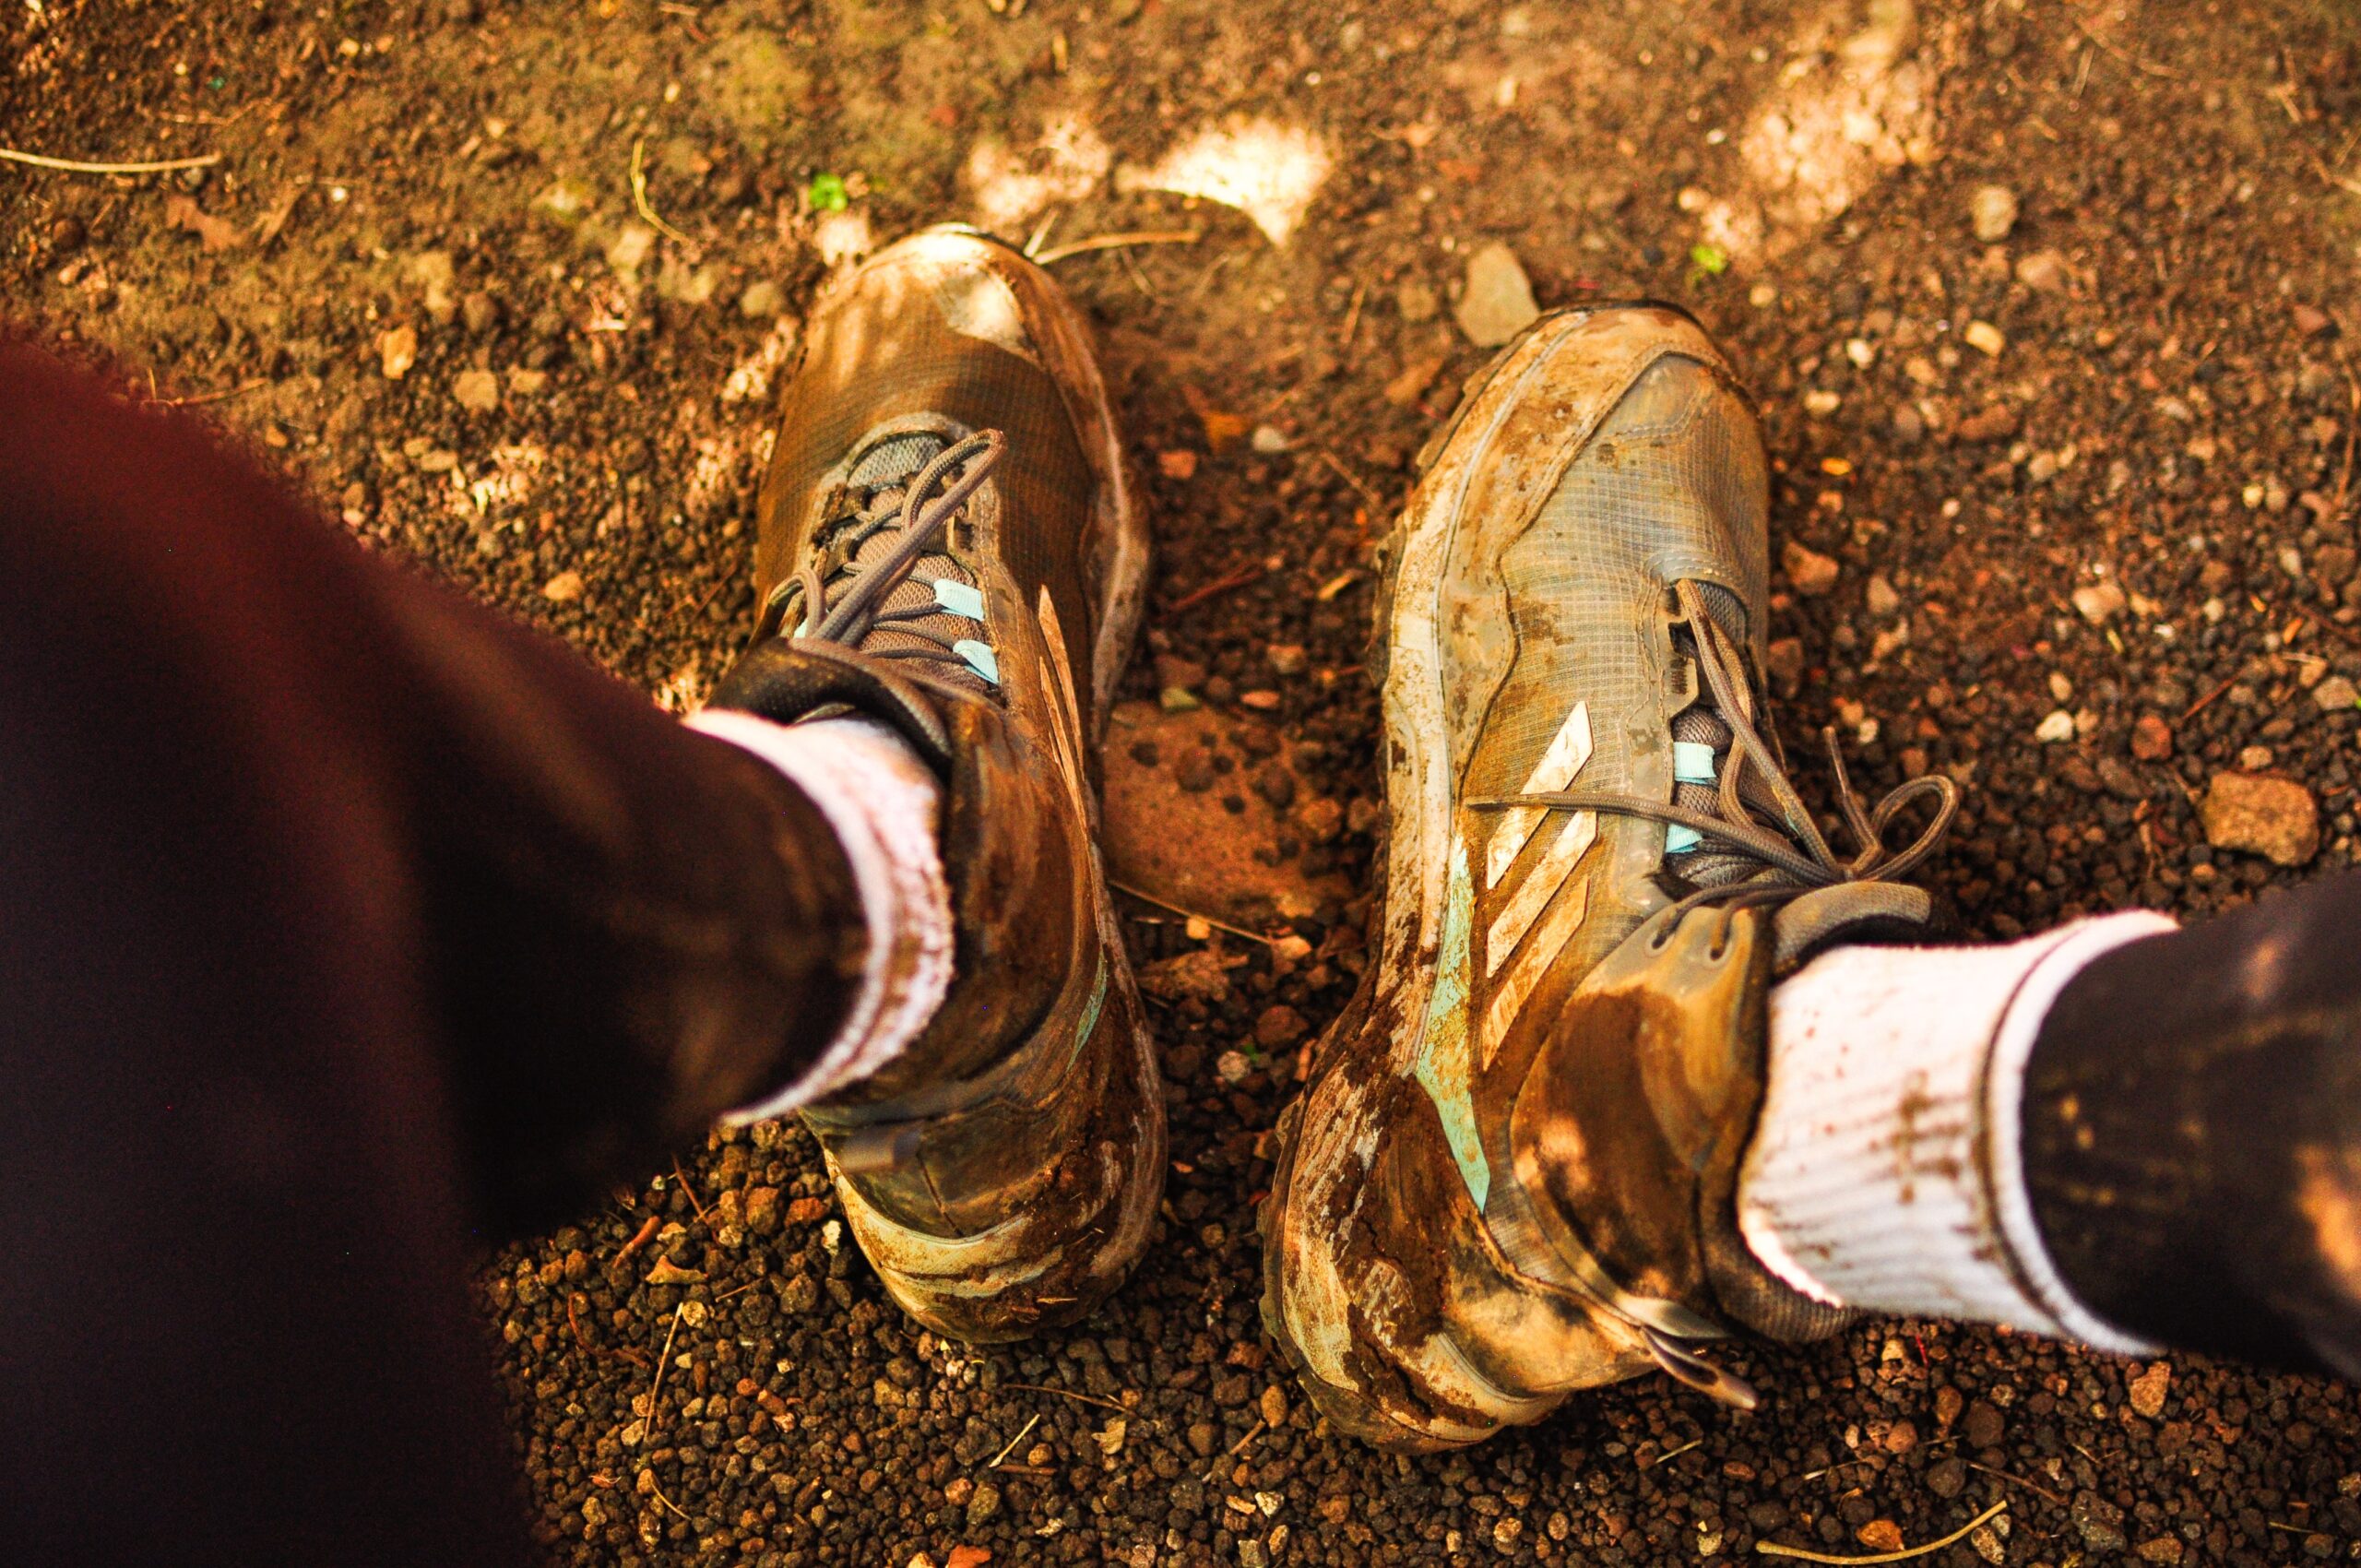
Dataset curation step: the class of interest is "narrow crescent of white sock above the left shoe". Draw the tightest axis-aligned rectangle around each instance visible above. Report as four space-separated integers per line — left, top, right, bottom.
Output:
687 708 952 1124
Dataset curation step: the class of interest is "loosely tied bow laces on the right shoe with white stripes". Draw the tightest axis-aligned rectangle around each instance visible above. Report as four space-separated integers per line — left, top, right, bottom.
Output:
1468 581 1960 919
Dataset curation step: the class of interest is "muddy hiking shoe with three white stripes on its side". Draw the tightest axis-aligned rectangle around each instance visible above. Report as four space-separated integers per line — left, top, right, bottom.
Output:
1261 307 1957 1450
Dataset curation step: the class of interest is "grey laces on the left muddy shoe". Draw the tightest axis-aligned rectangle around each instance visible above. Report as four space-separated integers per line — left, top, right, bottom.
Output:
781 430 1008 684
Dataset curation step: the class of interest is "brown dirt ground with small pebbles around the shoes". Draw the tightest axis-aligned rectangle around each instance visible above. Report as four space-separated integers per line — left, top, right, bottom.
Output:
0 0 2361 1568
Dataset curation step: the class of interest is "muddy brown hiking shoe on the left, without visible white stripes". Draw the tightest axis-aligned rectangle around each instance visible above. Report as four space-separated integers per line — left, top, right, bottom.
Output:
713 229 1164 1341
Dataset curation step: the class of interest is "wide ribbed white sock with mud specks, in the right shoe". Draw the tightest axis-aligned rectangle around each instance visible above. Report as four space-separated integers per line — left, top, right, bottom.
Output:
1738 911 2175 1353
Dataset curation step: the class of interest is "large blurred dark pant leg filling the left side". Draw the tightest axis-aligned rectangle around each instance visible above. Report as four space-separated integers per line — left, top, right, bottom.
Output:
0 345 861 1565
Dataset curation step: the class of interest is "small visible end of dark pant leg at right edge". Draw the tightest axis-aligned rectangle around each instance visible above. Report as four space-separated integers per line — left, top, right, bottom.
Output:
2023 873 2361 1377
